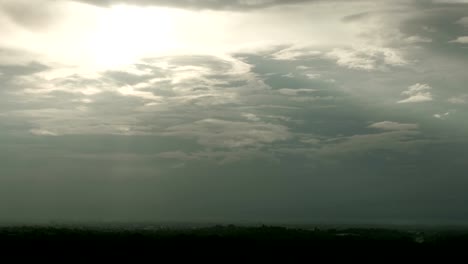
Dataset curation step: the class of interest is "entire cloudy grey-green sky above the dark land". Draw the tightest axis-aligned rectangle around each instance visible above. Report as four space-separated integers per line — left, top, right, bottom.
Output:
0 0 468 224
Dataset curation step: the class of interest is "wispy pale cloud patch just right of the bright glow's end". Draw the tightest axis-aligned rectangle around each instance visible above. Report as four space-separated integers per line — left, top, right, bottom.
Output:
327 46 408 71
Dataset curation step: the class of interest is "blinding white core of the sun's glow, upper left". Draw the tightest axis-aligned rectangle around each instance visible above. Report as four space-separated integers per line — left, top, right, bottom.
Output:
88 5 177 67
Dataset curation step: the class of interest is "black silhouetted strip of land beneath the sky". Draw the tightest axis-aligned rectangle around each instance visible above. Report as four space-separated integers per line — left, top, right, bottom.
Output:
0 225 468 256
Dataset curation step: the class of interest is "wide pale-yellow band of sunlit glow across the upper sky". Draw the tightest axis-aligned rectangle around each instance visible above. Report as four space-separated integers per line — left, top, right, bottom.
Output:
0 1 366 72
